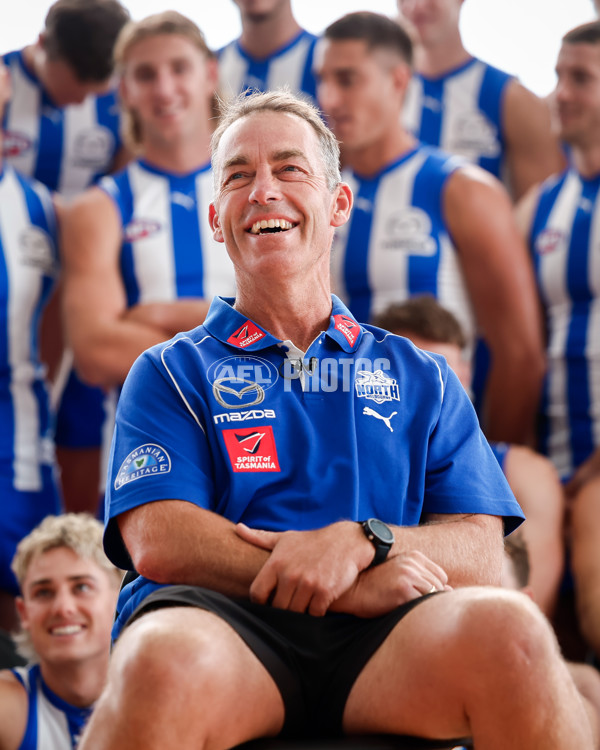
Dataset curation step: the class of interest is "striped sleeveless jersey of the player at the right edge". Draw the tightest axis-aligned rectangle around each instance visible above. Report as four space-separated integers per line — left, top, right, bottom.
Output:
530 169 600 478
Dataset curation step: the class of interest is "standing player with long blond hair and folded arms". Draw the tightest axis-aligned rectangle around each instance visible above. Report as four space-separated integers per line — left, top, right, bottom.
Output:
62 11 235 516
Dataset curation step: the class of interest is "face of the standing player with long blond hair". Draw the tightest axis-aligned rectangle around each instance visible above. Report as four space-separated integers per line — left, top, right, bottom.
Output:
121 34 216 148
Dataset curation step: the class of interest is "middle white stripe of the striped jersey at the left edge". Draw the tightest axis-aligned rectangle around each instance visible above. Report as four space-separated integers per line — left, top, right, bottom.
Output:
0 171 42 492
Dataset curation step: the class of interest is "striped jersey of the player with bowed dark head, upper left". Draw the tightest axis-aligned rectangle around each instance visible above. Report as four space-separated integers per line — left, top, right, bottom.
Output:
2 51 121 197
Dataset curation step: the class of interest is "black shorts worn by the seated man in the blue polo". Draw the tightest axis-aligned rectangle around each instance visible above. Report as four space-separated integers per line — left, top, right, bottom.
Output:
128 586 428 737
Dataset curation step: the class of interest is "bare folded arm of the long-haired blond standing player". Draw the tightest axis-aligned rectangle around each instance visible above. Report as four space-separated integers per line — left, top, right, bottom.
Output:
61 188 209 387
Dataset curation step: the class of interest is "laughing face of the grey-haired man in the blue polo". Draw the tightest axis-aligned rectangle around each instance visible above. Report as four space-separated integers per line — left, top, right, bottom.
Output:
210 112 351 283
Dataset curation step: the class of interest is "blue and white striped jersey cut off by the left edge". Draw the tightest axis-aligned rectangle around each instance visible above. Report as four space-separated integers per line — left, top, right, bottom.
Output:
0 166 58 502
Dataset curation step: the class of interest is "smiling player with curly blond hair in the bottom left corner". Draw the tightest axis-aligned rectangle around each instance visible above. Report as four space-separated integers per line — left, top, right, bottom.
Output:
0 513 121 750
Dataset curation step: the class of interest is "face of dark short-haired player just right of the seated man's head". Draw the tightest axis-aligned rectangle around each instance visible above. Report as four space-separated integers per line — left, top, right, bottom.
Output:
316 39 410 154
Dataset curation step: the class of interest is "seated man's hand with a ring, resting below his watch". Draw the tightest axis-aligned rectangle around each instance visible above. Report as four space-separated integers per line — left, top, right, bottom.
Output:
331 550 452 617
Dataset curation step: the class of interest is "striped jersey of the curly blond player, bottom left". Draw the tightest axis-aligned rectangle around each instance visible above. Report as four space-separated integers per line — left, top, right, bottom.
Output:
11 664 92 750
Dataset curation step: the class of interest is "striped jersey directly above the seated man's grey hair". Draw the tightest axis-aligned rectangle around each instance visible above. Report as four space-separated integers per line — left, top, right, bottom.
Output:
218 31 317 104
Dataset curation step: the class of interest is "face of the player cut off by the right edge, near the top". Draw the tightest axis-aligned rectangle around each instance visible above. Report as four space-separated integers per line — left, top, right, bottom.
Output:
551 44 600 147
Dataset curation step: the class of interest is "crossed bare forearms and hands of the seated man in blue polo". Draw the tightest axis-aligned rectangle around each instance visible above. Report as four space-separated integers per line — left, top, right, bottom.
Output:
118 500 502 617
